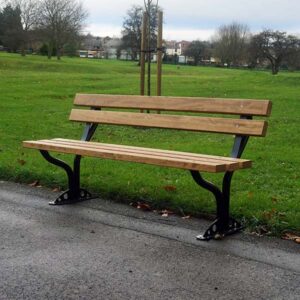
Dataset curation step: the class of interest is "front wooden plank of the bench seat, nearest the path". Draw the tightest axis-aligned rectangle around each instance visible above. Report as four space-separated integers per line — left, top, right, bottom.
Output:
23 140 230 173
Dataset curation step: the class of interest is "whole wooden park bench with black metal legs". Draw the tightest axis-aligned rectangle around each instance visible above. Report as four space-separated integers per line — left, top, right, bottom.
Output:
23 94 271 240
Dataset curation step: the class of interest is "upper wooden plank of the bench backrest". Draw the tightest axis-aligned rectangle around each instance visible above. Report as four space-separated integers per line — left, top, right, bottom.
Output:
74 94 272 116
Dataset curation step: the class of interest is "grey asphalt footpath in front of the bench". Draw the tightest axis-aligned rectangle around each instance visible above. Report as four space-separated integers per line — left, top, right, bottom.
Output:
0 182 300 300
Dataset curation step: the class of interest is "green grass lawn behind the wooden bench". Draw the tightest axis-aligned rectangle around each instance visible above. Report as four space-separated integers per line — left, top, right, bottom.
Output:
0 53 300 233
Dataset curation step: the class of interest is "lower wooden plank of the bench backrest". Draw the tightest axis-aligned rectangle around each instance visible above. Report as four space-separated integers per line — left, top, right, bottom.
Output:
70 109 267 136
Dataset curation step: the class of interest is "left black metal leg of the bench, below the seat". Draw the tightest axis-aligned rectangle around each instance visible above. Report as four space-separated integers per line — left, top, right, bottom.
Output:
40 150 92 205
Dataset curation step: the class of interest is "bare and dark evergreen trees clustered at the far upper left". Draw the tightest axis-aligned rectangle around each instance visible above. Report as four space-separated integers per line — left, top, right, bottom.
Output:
0 0 87 59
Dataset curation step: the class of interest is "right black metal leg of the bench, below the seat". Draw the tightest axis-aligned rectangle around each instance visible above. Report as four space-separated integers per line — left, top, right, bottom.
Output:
191 170 243 241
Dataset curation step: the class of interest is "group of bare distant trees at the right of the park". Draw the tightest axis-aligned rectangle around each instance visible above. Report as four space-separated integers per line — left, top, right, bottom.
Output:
184 23 300 74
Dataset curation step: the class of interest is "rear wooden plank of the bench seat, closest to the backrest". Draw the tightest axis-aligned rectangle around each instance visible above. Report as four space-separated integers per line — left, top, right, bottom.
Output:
52 138 252 169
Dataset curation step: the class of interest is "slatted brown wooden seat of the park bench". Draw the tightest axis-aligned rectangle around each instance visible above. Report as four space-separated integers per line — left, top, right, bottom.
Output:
23 139 251 173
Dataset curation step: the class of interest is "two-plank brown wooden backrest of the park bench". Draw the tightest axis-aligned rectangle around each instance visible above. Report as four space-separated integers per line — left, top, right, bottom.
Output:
70 94 271 136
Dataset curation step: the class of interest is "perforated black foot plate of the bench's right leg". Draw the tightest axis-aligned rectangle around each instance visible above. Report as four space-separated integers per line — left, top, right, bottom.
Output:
196 218 244 241
